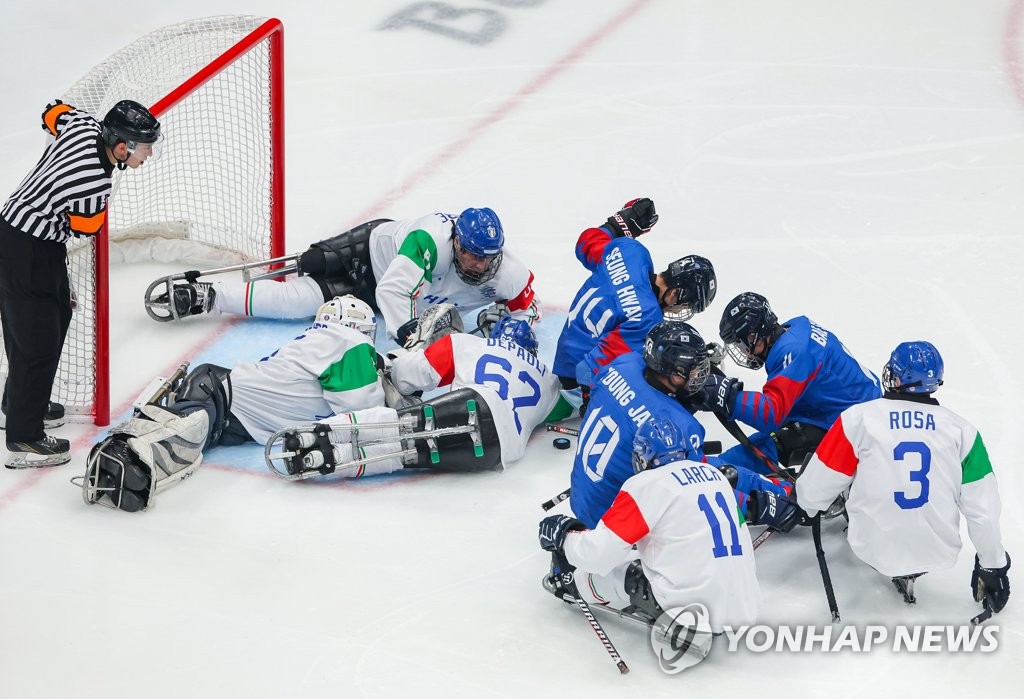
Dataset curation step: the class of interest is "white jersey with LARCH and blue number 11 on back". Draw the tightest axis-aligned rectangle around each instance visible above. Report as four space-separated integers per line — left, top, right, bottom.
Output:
565 460 761 632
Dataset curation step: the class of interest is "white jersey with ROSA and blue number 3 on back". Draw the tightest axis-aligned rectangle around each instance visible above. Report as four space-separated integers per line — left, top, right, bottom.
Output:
797 394 1007 577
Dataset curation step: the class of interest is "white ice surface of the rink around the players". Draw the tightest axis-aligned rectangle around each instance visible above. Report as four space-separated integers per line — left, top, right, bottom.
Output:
0 0 1024 699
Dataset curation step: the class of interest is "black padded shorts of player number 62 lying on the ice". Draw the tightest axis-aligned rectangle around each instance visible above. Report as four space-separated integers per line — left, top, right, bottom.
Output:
398 388 503 473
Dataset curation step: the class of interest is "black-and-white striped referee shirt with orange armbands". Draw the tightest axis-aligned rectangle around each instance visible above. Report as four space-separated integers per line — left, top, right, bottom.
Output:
0 99 114 243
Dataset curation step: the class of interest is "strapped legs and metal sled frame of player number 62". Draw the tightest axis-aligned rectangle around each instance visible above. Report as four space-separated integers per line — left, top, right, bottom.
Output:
265 388 504 480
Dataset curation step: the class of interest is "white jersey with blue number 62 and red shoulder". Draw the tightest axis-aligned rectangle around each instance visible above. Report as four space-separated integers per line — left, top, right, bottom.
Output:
391 333 568 466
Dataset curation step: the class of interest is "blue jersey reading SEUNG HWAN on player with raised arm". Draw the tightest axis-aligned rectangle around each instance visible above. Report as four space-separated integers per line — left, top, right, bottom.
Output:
552 228 662 385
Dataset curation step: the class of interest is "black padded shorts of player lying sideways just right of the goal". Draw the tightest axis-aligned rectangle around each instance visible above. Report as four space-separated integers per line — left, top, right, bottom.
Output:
299 218 391 312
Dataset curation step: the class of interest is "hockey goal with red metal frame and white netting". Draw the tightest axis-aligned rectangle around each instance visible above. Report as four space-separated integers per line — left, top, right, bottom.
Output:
0 16 285 425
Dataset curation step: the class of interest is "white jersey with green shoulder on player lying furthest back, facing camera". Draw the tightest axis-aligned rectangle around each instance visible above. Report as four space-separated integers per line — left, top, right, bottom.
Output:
370 213 539 339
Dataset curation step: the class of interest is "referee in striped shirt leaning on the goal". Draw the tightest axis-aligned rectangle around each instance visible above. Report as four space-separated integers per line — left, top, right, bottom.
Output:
0 99 160 469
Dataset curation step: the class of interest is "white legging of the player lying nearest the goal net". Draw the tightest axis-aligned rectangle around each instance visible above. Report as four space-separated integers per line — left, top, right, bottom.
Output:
213 276 324 319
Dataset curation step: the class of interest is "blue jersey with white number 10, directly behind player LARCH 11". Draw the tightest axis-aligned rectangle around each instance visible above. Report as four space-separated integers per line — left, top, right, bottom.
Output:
569 352 705 529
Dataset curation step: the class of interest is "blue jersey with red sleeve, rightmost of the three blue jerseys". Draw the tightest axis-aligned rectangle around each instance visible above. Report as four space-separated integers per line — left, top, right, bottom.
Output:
730 315 882 431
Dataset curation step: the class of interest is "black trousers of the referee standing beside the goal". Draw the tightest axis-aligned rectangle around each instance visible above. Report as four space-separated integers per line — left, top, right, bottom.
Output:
0 219 72 442
